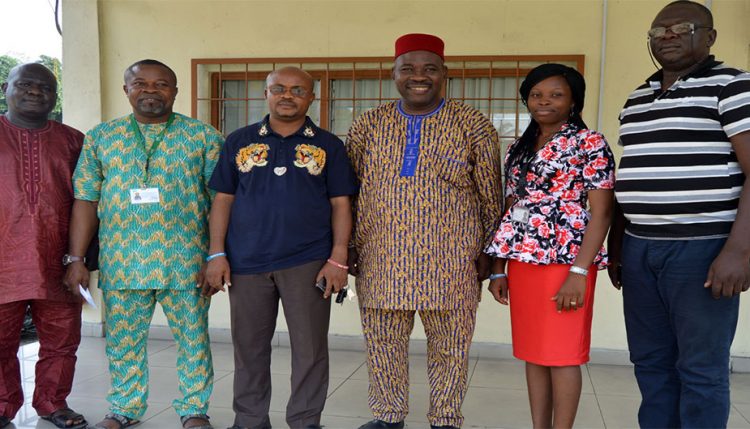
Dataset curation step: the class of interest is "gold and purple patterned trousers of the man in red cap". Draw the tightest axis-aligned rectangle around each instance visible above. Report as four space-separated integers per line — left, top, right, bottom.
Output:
360 308 476 427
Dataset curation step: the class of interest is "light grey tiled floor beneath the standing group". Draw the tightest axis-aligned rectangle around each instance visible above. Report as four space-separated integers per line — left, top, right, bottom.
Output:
10 338 750 429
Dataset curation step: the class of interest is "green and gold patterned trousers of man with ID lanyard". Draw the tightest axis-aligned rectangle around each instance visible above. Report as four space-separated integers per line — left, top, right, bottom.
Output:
104 289 214 419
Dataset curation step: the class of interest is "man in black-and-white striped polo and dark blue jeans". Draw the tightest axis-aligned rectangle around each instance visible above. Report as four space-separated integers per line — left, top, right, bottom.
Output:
609 1 750 428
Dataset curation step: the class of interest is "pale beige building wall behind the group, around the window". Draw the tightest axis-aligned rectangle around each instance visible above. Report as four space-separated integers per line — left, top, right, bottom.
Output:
63 0 750 356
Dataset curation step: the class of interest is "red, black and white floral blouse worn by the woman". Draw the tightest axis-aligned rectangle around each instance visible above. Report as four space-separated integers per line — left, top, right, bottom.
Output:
485 124 615 269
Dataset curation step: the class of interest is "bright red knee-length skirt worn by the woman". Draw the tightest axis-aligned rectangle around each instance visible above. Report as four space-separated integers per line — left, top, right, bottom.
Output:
508 260 596 366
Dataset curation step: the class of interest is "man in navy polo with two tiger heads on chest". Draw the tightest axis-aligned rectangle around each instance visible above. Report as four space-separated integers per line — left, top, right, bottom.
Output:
203 67 356 429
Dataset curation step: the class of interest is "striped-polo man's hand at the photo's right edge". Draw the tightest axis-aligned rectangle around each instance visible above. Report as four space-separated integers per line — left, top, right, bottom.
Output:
703 246 750 299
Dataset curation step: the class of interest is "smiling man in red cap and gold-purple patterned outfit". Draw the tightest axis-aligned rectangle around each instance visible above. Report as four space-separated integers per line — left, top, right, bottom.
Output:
346 34 502 429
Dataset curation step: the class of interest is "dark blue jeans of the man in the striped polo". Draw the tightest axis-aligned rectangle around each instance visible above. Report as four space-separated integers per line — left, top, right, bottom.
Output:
622 235 739 428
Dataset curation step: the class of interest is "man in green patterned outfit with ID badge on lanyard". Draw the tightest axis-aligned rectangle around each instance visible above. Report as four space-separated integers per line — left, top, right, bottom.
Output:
65 60 223 429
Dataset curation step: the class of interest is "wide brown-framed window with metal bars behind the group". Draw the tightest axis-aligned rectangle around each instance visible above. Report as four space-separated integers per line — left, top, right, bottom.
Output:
192 55 584 146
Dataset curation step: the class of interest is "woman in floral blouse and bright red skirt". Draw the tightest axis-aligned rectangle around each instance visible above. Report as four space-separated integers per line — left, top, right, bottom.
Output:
486 64 615 428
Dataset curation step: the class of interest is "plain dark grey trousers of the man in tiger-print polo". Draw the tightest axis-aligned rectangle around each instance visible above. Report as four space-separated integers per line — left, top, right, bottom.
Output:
229 261 331 429
